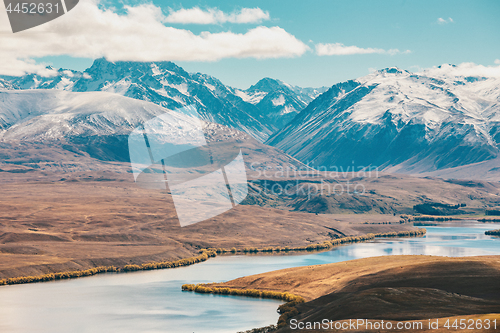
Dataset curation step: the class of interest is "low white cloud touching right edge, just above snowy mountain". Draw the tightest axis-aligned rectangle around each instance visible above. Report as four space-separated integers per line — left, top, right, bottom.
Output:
421 61 500 78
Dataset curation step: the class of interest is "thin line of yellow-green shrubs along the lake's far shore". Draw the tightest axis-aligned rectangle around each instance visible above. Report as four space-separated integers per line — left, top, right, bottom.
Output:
0 229 426 286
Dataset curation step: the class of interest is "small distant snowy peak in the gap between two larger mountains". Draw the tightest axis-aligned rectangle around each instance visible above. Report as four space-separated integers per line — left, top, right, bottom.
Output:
235 78 328 129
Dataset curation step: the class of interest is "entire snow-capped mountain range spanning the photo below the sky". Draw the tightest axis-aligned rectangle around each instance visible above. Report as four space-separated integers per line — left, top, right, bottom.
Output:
0 59 500 179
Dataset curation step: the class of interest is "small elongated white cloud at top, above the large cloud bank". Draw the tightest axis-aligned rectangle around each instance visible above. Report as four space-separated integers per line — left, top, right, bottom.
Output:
164 7 270 24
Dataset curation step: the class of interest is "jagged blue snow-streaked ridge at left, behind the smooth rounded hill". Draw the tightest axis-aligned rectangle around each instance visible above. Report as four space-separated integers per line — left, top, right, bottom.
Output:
0 58 319 141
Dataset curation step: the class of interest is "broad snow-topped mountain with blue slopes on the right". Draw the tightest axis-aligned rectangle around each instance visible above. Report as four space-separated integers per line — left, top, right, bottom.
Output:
267 67 500 173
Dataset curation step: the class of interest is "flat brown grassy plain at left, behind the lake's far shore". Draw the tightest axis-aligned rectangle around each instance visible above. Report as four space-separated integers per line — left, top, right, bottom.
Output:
0 172 424 280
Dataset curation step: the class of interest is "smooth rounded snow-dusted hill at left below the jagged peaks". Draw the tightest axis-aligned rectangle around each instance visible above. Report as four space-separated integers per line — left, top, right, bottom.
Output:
0 90 168 142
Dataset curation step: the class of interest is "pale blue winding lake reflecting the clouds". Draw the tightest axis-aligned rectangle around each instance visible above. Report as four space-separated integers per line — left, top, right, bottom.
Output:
0 222 500 333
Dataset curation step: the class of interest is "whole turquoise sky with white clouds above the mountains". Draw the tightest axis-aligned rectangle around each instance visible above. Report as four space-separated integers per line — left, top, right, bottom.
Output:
0 0 500 89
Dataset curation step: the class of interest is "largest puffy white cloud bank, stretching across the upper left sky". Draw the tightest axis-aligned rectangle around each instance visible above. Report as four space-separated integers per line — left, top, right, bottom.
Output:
0 0 309 75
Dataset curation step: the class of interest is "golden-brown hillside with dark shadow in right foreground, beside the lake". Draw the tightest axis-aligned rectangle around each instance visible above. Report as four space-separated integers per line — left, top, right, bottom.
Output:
210 256 500 332
